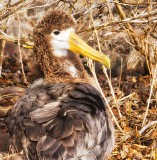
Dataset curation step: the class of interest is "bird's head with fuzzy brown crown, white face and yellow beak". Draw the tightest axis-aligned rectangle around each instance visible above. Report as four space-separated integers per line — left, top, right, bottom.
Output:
34 10 110 68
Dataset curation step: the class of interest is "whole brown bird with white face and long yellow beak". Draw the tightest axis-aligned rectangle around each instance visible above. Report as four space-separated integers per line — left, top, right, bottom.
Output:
8 9 115 160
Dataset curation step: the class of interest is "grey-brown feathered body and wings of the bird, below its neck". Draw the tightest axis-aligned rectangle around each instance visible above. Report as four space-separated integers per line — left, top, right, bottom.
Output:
9 80 114 160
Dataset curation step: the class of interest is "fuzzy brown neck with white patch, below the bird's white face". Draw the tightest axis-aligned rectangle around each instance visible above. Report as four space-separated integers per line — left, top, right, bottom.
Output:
39 51 90 83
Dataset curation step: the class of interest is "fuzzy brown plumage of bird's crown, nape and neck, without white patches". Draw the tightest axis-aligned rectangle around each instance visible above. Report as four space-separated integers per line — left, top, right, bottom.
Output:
34 10 88 83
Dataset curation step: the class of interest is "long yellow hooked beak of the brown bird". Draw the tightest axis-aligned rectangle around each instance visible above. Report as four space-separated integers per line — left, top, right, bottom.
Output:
68 32 110 68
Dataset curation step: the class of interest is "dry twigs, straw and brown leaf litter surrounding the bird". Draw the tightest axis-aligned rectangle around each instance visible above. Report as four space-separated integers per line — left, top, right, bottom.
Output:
0 0 157 160
